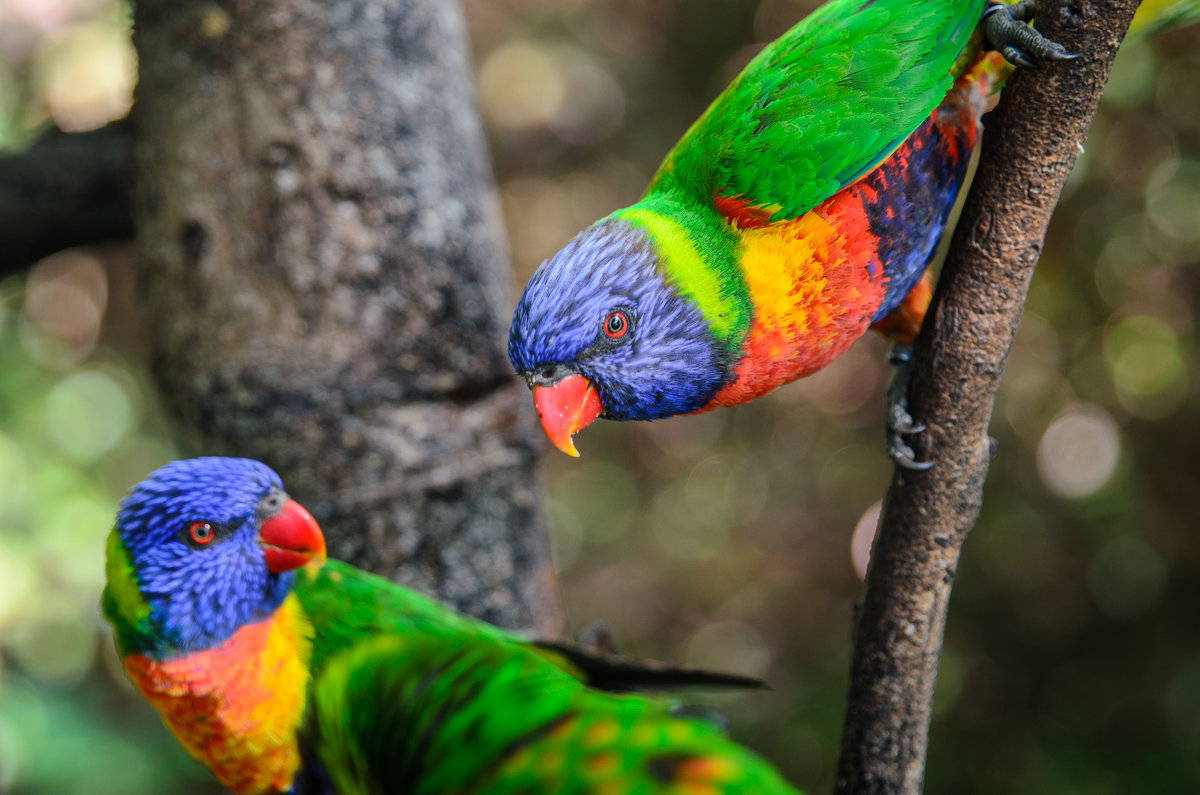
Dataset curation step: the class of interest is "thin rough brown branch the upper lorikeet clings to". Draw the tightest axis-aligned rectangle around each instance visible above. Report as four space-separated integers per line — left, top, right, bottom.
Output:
835 0 1138 793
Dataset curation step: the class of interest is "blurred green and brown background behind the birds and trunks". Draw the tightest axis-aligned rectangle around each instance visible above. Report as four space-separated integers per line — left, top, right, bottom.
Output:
0 0 1200 795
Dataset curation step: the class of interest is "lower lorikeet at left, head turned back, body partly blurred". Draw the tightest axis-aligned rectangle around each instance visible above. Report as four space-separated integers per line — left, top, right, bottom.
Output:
102 458 796 795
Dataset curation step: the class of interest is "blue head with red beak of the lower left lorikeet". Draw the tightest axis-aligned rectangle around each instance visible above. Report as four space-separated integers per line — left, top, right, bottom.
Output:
103 458 325 654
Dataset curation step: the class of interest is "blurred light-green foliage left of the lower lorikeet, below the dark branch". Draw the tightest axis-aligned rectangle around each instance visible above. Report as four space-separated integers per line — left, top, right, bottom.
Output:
0 251 213 795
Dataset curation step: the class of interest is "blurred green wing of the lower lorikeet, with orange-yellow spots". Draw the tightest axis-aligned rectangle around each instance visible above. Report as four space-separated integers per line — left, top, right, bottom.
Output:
306 635 794 795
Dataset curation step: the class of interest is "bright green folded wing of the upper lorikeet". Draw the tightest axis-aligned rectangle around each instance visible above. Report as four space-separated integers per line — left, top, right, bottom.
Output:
648 0 984 221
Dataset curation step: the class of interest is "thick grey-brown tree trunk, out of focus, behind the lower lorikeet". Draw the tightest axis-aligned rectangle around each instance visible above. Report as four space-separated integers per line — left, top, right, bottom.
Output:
134 0 558 632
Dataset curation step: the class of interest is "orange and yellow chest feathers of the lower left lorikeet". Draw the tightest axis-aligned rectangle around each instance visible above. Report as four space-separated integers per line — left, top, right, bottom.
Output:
125 596 312 795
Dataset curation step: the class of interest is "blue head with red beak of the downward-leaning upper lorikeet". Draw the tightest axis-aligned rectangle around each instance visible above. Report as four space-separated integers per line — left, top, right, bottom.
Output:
509 217 730 455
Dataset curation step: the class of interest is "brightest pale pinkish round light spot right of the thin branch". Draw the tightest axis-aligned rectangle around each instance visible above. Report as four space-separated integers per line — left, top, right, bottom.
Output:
1037 404 1121 498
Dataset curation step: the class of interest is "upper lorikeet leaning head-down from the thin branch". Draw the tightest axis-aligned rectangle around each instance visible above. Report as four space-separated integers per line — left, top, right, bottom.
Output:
509 0 1069 464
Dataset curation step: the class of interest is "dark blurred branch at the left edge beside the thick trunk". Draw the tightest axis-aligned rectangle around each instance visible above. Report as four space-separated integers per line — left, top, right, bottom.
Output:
0 122 133 275
